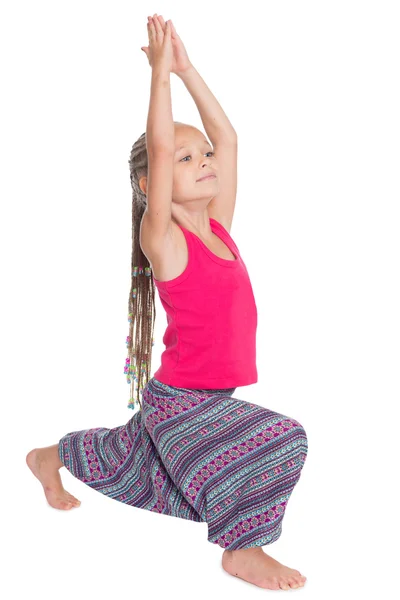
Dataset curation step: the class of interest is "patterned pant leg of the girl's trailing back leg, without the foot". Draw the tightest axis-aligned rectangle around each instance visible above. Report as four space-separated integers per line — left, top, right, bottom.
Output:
52 410 201 521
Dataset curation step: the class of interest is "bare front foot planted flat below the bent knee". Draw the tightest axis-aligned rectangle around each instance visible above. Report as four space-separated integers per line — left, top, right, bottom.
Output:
222 546 307 590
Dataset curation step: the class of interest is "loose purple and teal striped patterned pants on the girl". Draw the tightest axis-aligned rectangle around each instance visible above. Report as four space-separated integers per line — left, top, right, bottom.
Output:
59 377 308 550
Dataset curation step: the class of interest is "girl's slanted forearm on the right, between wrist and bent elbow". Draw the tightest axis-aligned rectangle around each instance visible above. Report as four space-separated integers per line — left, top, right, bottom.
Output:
178 65 236 144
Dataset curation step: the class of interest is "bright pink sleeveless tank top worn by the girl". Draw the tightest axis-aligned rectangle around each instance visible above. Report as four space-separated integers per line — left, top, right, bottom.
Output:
153 218 258 389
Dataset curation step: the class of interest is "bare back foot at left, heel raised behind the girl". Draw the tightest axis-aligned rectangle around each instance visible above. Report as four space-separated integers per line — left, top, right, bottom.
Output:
26 444 80 510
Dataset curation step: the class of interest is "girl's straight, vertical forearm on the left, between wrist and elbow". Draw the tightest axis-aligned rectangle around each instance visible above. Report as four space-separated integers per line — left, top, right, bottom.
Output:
146 70 175 154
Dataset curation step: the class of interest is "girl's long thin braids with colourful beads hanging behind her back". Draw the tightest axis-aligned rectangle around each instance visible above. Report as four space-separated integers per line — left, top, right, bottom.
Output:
124 133 156 409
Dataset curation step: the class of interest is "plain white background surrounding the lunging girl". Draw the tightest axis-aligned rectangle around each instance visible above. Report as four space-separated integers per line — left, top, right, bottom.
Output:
0 0 400 600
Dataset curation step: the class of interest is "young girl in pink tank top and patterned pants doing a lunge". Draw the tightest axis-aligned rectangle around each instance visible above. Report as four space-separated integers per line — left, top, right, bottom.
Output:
26 15 308 589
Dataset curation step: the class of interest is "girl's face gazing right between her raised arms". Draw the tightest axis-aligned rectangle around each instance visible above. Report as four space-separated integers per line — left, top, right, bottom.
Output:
172 125 218 205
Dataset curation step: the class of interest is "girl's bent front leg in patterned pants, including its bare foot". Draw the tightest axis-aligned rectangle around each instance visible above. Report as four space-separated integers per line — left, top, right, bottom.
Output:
144 380 308 589
